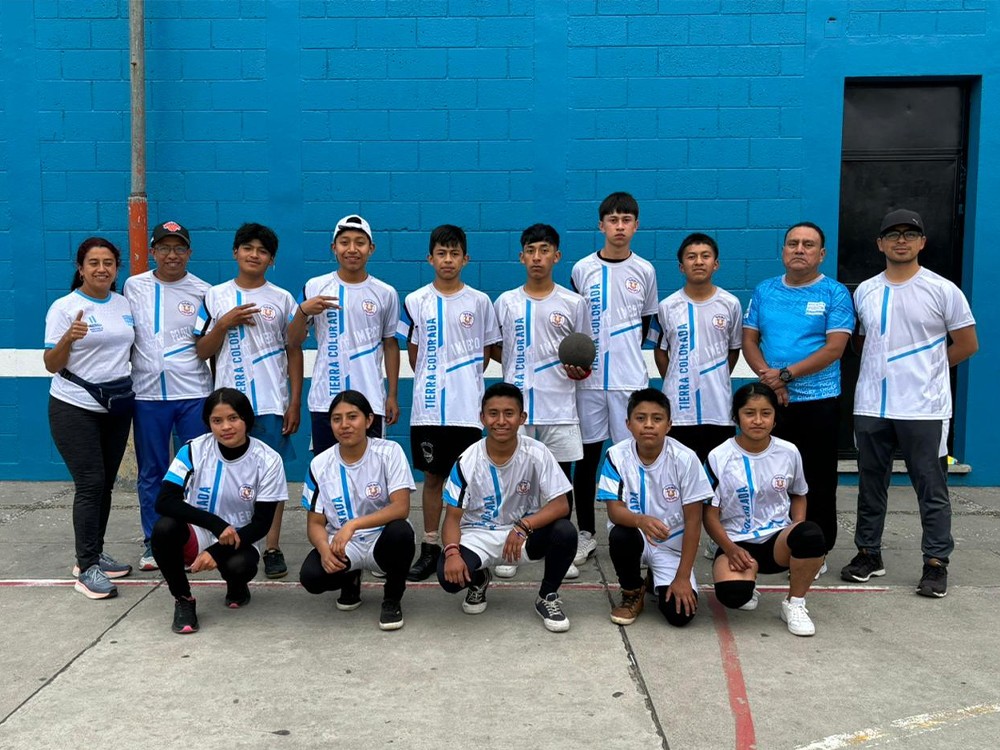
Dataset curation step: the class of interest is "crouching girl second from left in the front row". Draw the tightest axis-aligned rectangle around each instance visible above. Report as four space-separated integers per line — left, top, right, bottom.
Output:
299 391 416 630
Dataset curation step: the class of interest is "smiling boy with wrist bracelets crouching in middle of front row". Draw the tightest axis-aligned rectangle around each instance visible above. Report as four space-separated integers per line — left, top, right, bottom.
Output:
437 383 577 633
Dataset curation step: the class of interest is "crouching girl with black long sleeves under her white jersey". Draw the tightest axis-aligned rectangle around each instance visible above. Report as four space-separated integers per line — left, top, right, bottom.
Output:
150 388 288 633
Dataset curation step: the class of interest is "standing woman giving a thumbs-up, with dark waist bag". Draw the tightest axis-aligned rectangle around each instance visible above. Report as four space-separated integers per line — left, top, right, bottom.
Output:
44 237 135 599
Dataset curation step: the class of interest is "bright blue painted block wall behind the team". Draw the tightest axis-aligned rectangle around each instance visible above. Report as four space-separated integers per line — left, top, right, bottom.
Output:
0 0 1000 484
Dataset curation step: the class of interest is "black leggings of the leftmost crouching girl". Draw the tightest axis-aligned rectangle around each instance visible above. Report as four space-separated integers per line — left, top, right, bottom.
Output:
150 516 260 598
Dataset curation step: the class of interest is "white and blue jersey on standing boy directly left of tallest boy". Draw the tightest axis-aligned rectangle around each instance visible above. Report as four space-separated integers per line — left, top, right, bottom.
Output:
494 284 586 425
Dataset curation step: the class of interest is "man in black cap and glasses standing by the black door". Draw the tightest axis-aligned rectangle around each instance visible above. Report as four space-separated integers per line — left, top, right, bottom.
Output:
840 209 979 598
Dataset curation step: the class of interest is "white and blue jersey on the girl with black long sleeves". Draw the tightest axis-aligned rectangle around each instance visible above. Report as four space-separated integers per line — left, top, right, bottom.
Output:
163 433 288 551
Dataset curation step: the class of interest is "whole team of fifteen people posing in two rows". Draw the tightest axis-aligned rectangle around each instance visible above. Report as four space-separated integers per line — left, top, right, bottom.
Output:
45 193 978 636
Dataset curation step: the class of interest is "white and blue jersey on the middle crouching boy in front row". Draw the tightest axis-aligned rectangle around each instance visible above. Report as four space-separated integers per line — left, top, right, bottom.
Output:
444 435 573 533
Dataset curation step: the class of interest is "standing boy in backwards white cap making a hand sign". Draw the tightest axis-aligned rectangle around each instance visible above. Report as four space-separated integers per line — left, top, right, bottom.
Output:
288 215 399 456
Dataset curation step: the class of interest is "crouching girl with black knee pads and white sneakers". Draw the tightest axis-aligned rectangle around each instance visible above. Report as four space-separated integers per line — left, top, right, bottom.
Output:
704 383 826 636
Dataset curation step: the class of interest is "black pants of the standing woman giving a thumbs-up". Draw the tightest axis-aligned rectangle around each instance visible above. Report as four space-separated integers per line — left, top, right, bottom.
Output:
49 396 132 570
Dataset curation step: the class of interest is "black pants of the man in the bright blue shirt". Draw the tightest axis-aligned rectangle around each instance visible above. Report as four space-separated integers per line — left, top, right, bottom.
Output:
774 398 840 551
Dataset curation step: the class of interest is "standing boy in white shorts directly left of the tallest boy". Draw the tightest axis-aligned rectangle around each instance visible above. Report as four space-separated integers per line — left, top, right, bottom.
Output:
492 224 589 578
